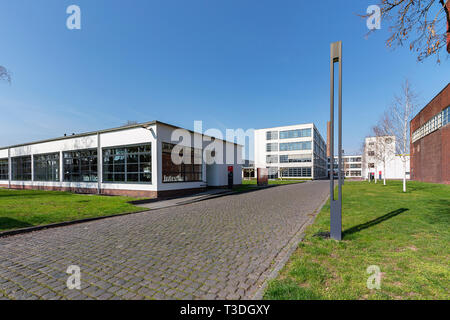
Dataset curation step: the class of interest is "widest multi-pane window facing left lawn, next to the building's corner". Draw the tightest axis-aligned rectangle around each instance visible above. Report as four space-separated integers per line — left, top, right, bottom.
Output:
102 143 152 183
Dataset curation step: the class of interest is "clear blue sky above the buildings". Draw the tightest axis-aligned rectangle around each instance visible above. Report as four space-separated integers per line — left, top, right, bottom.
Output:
0 0 450 159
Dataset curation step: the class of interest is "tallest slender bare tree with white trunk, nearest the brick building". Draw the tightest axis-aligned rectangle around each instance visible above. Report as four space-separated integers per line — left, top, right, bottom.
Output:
387 80 417 192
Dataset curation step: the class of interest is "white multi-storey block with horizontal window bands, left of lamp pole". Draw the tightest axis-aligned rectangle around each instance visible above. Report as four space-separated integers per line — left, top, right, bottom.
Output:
254 123 327 179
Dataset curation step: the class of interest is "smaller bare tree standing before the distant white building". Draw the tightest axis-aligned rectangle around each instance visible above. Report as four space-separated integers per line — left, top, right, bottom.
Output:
372 112 395 185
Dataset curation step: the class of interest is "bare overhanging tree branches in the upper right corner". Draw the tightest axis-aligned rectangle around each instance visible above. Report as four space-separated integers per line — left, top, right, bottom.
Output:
364 0 450 63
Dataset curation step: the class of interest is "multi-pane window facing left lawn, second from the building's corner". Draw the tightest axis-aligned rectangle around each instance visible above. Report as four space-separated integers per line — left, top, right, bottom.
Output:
63 149 98 182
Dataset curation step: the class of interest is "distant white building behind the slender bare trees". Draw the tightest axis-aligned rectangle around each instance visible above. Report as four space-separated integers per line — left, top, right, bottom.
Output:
362 136 410 179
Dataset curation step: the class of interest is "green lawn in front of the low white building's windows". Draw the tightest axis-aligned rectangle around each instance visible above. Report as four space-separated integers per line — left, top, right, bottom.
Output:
0 189 147 231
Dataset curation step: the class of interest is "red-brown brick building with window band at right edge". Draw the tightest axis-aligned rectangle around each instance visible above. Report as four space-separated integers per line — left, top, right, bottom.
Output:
410 83 450 184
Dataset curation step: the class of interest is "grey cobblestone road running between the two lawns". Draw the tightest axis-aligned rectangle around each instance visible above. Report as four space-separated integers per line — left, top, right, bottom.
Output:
0 181 328 299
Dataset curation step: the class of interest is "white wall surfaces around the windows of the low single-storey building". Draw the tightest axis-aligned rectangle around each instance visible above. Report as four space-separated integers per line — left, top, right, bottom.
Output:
0 123 242 191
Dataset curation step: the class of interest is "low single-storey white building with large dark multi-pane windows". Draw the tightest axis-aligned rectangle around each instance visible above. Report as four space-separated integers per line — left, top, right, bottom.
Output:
0 121 242 198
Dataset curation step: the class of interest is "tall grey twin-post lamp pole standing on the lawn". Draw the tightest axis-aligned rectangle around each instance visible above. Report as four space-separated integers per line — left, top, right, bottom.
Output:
330 41 342 240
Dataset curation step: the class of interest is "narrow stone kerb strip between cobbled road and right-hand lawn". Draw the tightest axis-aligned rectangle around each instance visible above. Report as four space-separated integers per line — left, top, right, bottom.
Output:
250 195 330 300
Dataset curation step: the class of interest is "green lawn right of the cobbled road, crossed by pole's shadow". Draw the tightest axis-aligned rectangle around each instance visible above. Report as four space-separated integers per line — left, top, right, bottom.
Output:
265 181 450 299
